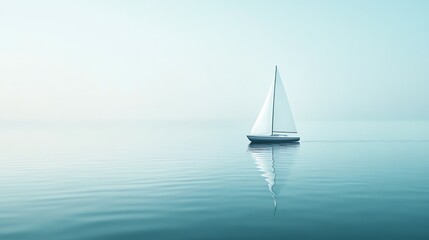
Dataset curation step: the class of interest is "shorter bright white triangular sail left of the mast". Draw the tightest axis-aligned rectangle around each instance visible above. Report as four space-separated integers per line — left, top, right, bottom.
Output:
250 84 274 135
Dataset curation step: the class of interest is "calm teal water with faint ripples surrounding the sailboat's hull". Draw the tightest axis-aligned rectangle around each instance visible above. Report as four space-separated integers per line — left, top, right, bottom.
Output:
0 122 429 239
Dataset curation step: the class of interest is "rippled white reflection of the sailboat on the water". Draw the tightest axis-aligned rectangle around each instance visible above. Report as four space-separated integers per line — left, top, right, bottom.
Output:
248 142 299 210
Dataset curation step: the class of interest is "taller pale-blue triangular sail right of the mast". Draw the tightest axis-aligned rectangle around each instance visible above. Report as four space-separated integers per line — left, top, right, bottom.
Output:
272 67 296 133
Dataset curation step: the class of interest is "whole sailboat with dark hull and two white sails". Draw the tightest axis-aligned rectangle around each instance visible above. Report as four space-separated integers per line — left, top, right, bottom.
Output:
247 66 300 142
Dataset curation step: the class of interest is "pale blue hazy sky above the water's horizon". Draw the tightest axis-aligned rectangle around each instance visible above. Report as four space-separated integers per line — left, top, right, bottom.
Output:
0 0 429 121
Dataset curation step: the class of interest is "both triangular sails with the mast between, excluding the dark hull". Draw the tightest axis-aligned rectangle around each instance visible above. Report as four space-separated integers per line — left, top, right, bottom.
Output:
251 66 296 135
